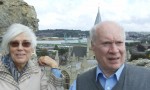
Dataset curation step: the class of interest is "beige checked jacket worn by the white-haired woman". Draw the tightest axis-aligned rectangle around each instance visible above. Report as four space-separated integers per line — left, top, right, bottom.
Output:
0 60 64 90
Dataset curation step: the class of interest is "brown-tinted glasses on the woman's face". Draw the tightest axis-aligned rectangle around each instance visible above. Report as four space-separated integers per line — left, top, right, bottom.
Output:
10 41 31 47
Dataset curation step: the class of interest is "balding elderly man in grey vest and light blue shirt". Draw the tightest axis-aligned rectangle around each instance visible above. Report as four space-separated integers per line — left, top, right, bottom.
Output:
70 21 150 90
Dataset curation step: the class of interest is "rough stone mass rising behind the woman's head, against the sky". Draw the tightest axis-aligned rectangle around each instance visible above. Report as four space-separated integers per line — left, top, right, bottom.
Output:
0 0 38 35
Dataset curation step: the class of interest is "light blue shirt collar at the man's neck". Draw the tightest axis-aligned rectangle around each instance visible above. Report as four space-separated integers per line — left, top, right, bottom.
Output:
96 64 124 81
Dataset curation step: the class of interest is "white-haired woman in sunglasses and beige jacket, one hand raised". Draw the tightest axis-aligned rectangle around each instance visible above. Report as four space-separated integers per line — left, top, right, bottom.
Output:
0 24 63 90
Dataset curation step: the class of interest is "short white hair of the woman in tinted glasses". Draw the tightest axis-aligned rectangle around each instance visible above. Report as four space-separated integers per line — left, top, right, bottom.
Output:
1 23 37 54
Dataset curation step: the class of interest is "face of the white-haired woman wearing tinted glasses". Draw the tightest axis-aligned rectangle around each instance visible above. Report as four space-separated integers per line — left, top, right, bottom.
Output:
9 33 33 66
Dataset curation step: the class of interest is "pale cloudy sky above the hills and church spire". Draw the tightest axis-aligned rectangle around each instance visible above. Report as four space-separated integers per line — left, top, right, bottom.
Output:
24 0 150 32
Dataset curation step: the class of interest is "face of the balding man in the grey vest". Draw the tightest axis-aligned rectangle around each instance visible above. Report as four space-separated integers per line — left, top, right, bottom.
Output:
92 22 126 72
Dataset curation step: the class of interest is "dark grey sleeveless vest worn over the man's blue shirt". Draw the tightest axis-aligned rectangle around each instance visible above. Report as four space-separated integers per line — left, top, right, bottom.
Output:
76 64 150 90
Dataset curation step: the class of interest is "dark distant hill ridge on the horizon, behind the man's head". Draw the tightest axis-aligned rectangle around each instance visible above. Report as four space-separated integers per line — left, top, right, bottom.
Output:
35 29 150 41
